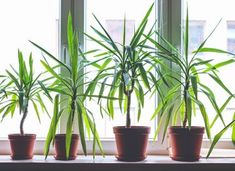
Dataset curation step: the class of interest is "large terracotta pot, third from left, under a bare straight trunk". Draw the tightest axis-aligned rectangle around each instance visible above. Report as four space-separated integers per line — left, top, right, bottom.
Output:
113 126 150 161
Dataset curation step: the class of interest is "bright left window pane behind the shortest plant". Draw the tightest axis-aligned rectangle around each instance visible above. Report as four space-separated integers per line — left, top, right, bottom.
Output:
0 0 59 137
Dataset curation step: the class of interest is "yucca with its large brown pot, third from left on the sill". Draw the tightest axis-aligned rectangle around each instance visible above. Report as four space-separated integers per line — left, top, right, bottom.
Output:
85 4 163 161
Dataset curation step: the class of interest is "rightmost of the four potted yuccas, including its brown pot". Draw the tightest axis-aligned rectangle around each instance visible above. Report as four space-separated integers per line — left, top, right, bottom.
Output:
148 7 234 161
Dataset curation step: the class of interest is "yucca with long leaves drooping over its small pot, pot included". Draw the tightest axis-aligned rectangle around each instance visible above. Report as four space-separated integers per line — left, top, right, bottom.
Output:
31 14 103 160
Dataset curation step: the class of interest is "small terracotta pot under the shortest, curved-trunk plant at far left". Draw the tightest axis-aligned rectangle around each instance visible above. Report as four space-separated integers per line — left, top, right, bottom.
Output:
8 134 36 160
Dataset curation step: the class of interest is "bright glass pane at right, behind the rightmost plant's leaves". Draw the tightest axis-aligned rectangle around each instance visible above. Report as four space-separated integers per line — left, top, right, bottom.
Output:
184 0 235 139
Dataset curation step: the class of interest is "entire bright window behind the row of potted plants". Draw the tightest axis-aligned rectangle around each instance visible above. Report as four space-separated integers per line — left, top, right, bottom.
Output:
0 0 235 154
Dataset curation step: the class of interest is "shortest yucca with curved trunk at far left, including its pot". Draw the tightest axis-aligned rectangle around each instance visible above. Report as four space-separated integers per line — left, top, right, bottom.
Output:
0 50 50 159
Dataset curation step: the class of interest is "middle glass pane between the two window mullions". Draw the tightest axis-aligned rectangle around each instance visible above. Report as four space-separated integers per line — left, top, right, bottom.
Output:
86 0 156 138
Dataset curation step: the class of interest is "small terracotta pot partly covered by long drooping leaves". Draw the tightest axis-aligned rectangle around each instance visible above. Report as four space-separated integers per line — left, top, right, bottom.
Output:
55 134 79 160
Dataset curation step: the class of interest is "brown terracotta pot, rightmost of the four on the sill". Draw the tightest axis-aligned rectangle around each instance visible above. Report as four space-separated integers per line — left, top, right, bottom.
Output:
169 126 204 161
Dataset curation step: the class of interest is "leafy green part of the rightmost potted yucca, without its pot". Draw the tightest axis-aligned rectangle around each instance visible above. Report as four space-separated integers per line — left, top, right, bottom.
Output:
148 6 235 142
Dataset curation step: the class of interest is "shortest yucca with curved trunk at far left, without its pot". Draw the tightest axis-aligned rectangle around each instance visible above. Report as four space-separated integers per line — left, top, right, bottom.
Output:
0 50 51 135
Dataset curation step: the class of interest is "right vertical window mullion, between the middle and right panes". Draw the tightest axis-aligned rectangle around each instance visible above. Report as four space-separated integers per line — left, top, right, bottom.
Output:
157 0 182 150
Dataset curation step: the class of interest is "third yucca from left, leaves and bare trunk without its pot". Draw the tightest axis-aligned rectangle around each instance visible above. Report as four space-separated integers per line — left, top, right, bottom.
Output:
85 4 165 127
